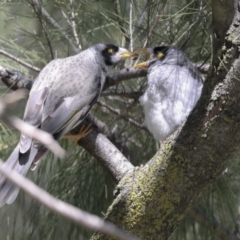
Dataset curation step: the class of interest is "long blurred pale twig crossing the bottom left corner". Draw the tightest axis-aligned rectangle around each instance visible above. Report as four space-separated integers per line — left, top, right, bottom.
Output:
0 160 138 240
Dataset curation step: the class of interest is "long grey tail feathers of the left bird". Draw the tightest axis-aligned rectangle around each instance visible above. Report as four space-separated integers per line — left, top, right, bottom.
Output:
0 144 37 207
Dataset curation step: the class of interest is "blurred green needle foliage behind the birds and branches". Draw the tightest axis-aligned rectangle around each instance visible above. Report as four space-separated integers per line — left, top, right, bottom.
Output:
0 0 240 240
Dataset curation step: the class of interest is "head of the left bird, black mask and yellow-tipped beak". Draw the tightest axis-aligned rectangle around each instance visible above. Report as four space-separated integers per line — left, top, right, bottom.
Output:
95 43 137 66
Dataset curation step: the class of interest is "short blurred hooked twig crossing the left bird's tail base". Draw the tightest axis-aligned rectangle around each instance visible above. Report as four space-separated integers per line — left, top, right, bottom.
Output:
0 89 66 158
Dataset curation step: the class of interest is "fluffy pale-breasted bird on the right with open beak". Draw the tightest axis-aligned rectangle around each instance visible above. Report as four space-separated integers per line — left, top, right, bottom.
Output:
134 46 204 142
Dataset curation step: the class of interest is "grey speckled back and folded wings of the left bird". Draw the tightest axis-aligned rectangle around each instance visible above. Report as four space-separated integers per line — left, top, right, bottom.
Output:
19 56 102 164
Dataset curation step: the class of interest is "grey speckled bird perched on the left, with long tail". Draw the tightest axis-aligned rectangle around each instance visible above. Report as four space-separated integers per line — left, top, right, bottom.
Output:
0 43 133 206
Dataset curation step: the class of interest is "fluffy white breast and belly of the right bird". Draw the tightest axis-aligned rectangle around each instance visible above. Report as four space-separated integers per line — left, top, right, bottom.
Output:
140 65 202 141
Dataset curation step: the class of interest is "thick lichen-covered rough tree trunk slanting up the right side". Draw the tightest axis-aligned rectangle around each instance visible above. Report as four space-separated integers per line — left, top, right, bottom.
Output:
92 0 240 240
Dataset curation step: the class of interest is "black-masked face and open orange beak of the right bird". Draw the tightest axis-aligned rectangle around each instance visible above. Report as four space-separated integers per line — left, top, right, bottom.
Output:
133 46 171 68
